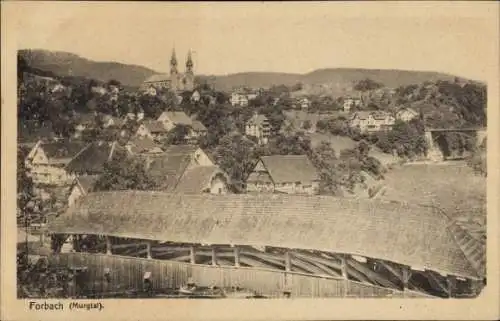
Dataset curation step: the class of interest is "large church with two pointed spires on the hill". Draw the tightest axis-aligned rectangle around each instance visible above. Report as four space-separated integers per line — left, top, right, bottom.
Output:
142 49 194 92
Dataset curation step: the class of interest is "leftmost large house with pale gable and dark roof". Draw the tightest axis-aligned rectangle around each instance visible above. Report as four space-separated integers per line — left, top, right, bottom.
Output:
26 141 86 186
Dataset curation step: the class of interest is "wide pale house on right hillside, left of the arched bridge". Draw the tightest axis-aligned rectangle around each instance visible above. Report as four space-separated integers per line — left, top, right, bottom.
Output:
349 111 395 133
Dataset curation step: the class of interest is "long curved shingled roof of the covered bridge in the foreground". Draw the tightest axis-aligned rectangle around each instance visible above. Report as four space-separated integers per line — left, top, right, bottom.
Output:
48 191 483 278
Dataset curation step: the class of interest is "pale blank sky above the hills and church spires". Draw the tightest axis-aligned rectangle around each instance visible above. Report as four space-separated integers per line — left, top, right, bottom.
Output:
8 1 499 80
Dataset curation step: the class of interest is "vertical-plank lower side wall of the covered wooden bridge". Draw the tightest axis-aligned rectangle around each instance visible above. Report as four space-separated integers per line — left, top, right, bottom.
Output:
50 252 436 298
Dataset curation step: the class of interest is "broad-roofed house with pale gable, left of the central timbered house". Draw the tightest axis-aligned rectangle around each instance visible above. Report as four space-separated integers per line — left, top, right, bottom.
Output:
146 145 230 194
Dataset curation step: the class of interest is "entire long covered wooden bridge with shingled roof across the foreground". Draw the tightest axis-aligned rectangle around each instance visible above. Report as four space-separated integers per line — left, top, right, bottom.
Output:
48 191 485 297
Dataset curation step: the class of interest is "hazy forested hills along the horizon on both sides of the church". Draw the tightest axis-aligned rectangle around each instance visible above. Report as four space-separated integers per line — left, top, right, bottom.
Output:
19 49 476 95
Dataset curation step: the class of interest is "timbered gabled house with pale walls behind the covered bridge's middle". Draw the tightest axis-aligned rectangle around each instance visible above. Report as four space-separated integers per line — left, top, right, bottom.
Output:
246 155 319 195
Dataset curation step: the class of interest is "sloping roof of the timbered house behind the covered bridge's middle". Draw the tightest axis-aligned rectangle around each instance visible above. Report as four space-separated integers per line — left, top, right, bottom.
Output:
261 155 319 184
